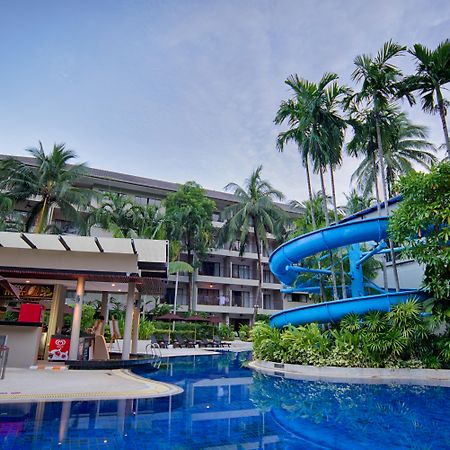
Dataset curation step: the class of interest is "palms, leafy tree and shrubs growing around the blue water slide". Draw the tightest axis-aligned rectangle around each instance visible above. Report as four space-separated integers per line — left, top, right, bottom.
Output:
252 40 450 368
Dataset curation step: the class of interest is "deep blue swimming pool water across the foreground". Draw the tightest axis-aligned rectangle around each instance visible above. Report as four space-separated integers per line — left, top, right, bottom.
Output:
0 353 450 450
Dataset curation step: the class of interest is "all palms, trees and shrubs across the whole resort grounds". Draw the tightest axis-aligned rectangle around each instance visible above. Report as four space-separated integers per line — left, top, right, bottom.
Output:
0 40 450 367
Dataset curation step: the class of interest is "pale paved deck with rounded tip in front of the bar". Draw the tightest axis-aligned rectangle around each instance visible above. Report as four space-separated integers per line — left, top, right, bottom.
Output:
0 368 183 403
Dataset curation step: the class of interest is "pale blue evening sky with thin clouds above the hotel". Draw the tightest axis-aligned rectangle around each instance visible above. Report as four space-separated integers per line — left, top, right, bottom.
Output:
0 0 450 204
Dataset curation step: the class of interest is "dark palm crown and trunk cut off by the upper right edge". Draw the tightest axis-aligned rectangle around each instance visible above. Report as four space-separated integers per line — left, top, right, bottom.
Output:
401 39 450 158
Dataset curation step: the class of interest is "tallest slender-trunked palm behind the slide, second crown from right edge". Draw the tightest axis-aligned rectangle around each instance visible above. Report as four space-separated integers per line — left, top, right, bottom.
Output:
352 41 412 291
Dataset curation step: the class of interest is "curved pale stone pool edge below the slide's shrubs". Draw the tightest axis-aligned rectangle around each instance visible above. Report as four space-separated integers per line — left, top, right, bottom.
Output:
249 360 450 387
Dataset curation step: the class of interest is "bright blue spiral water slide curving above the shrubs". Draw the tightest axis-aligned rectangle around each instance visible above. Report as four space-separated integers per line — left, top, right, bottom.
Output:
269 217 425 328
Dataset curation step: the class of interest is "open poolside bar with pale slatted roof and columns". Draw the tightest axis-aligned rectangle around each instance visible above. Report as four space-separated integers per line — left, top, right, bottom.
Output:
0 232 168 367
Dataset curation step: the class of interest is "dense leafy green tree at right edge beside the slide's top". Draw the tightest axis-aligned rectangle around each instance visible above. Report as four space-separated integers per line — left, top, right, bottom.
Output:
389 163 450 322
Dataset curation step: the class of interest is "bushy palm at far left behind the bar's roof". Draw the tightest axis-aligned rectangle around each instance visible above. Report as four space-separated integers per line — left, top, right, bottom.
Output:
0 142 91 233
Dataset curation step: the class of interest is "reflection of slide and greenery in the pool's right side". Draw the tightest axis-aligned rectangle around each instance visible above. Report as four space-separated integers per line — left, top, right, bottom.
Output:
250 374 450 449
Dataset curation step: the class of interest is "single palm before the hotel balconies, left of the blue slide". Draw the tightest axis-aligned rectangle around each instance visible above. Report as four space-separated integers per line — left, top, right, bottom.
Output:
219 166 285 319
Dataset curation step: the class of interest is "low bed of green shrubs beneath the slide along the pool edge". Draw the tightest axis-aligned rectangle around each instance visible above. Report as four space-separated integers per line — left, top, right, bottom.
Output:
252 300 450 368
